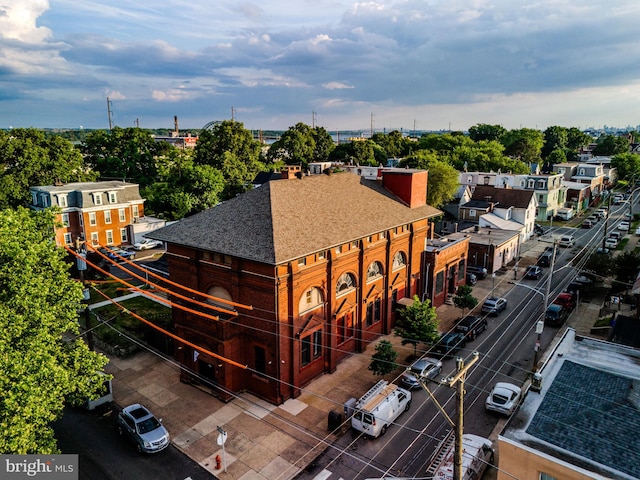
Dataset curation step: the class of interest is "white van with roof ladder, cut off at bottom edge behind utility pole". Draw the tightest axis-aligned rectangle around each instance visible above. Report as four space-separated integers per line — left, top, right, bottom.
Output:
427 432 494 480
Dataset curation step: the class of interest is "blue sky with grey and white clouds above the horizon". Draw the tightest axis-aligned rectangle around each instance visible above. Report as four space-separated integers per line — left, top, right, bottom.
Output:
0 0 640 131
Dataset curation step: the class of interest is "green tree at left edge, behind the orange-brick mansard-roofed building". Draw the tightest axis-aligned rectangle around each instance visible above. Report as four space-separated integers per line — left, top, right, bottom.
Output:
0 128 95 208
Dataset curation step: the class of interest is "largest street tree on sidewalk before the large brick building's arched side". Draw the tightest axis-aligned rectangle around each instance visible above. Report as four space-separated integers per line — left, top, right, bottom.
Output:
394 295 440 356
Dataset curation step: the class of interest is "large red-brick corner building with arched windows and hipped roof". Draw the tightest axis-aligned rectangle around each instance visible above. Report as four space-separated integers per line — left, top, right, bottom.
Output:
149 170 441 404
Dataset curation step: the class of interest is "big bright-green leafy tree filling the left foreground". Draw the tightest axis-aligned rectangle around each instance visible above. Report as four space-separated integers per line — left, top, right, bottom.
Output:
0 207 108 454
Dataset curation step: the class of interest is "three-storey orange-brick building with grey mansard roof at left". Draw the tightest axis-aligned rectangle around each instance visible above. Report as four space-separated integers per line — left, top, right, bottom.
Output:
29 181 144 246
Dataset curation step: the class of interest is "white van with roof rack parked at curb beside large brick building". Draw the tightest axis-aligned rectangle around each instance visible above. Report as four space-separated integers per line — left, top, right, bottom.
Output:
351 380 411 438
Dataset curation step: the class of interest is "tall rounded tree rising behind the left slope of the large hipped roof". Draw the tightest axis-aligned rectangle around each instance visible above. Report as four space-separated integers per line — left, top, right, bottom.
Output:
194 120 265 200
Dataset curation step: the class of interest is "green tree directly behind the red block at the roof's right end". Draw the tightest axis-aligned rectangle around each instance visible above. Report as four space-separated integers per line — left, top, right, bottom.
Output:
400 150 459 208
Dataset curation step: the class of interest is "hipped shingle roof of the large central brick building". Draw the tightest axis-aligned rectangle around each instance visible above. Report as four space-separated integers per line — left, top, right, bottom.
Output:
147 173 442 265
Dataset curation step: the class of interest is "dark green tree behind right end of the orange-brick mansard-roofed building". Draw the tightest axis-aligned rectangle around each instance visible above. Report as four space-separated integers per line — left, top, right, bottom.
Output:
81 127 170 187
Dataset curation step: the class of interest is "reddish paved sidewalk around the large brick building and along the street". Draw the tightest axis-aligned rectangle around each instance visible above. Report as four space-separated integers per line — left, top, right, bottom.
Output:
106 242 601 480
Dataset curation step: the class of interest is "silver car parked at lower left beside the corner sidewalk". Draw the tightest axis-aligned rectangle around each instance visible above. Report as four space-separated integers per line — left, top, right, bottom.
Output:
118 403 170 453
